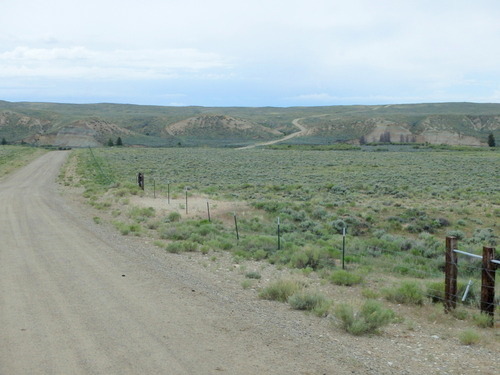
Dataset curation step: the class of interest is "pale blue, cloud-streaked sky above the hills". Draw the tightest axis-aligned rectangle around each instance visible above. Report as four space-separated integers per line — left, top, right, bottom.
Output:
0 0 500 107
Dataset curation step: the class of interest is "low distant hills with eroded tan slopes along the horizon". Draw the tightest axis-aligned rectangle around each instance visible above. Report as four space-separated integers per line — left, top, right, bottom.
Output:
0 101 500 147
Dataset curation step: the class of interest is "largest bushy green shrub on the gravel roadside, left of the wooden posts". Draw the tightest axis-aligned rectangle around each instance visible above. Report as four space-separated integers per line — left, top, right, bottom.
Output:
335 300 395 336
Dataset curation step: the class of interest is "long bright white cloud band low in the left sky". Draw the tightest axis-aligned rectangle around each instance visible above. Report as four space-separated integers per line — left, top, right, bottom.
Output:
0 46 231 79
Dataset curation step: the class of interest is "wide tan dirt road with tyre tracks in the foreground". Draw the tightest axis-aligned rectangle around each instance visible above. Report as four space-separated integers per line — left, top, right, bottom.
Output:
0 152 352 375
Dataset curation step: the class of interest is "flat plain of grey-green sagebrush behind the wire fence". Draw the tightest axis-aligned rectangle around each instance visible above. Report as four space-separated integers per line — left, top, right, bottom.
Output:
71 148 500 322
